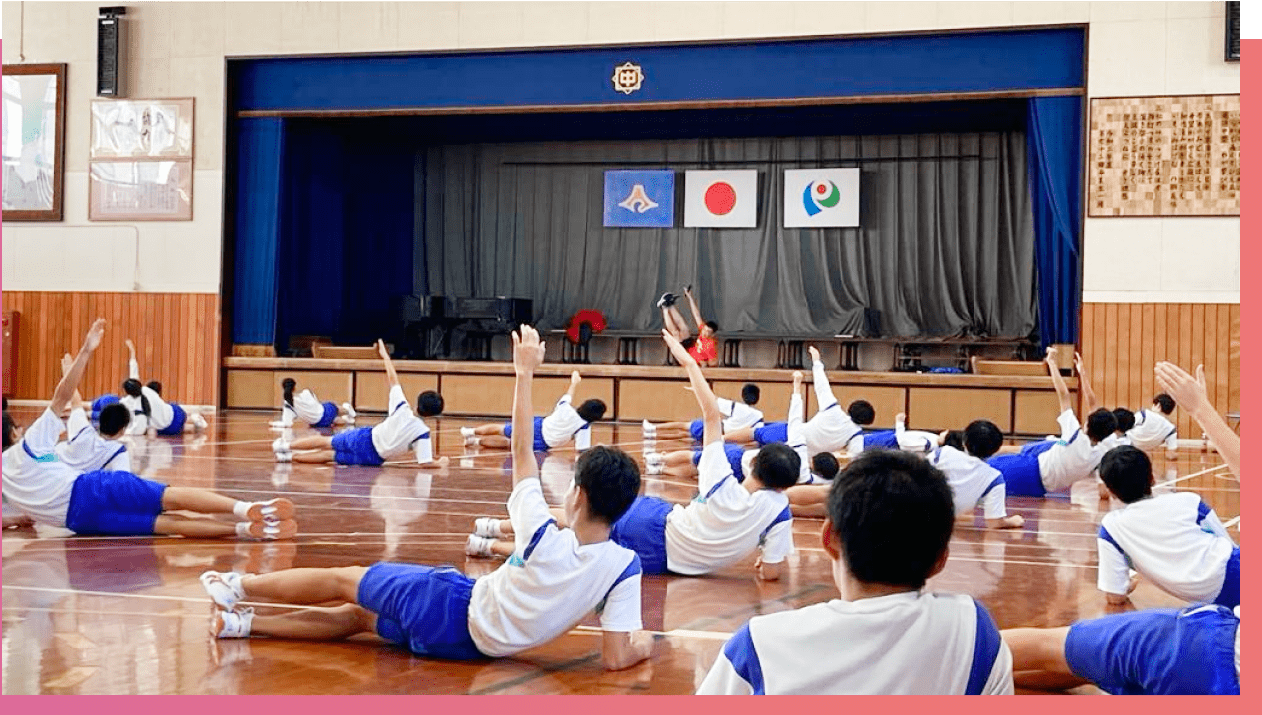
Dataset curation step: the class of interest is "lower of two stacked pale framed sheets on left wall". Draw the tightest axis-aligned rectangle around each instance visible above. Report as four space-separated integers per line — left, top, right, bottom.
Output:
87 159 193 221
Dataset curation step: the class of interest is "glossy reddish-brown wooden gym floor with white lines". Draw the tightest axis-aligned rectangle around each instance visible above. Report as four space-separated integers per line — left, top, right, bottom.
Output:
3 410 1239 694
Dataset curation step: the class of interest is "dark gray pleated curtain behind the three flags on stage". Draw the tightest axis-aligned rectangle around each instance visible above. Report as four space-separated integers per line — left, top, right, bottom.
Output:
414 132 1037 337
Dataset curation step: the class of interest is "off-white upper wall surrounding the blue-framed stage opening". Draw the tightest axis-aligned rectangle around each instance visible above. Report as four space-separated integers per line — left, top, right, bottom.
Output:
3 1 1239 303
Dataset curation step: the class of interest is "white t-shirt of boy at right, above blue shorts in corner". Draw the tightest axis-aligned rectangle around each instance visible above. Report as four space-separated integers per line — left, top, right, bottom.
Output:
1095 492 1235 602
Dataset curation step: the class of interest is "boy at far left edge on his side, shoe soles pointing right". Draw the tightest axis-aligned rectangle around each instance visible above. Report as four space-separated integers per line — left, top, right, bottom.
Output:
4 319 298 538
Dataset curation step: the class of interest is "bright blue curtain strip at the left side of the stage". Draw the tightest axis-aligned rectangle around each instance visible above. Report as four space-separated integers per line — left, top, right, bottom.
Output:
232 117 285 344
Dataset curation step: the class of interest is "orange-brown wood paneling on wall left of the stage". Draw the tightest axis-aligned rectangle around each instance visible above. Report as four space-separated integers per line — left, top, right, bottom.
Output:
4 290 220 405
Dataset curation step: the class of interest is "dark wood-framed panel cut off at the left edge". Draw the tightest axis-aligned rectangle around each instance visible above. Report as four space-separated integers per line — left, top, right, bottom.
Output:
3 64 66 221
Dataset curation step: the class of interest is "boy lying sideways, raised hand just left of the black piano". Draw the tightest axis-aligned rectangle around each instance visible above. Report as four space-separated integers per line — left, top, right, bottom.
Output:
271 340 448 467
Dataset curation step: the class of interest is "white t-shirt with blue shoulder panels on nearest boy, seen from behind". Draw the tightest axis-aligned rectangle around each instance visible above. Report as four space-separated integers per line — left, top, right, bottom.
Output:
697 591 1013 695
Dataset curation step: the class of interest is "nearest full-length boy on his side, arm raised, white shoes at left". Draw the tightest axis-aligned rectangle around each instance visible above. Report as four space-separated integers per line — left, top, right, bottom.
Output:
202 325 652 670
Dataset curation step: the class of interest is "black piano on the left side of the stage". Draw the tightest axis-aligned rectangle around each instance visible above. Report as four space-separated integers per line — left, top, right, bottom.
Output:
398 295 534 361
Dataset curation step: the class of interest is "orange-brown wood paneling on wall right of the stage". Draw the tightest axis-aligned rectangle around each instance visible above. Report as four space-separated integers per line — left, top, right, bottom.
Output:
1083 303 1241 439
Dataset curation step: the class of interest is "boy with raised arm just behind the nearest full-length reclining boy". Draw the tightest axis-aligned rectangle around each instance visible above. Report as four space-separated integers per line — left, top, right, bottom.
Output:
466 330 799 580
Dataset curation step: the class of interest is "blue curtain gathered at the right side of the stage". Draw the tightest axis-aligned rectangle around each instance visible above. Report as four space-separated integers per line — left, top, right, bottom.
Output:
1026 97 1083 347
